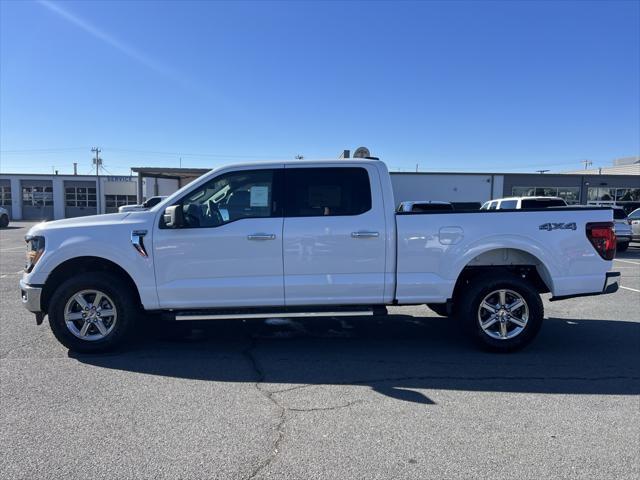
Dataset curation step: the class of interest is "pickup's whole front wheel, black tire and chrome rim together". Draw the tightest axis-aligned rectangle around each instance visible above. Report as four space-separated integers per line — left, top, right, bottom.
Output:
49 272 138 353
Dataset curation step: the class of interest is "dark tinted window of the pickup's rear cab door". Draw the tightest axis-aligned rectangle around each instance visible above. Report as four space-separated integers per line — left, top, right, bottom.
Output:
284 167 371 217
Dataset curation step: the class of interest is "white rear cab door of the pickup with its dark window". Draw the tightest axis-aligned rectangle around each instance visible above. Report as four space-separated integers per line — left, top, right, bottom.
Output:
283 164 386 305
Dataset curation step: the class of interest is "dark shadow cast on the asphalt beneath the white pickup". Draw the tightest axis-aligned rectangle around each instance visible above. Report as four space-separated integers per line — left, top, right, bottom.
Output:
70 315 640 404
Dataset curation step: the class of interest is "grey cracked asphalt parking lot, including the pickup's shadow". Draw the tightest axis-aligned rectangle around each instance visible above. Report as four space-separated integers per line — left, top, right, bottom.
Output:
0 222 640 479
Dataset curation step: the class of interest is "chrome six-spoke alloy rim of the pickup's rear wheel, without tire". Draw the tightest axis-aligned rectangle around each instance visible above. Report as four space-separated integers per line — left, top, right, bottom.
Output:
478 289 529 340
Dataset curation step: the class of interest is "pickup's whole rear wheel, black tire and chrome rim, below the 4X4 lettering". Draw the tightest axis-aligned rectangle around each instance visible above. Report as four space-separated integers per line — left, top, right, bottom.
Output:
459 274 544 352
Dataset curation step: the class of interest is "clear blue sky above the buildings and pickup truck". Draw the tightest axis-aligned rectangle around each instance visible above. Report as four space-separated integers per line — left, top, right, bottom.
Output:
0 1 640 173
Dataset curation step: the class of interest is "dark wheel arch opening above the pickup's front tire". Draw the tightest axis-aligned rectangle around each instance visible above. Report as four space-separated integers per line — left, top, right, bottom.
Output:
41 256 142 312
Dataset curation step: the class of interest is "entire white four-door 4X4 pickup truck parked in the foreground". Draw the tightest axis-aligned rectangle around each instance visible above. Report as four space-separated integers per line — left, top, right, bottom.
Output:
20 159 620 352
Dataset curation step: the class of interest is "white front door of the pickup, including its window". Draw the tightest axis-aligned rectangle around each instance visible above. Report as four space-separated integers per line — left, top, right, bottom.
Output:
153 168 284 309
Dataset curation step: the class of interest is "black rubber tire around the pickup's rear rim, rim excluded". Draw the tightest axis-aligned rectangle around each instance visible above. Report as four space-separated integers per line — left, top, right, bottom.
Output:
456 273 544 352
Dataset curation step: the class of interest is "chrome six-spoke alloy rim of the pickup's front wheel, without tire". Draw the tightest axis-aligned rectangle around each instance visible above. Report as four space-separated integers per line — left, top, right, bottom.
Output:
64 290 118 341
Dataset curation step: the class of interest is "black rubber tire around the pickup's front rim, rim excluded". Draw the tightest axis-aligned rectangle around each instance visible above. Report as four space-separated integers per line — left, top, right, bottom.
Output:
48 272 140 353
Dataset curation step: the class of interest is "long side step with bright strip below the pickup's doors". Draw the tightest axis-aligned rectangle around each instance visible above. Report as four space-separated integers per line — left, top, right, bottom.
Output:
162 306 387 321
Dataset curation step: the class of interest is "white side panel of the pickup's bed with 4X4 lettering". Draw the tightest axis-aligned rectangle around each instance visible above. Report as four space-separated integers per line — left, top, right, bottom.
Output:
396 207 613 304
